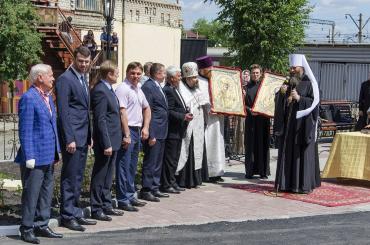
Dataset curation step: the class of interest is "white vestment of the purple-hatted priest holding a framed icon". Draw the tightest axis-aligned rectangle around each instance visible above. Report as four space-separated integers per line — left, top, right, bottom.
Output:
198 76 225 177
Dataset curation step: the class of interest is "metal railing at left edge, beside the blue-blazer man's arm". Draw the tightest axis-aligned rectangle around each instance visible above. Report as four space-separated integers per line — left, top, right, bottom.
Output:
0 113 20 162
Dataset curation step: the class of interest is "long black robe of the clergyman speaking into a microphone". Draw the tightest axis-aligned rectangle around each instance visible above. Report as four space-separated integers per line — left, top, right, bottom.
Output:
274 75 321 193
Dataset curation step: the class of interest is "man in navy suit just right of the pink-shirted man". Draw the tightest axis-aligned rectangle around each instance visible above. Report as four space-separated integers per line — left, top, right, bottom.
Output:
139 63 169 202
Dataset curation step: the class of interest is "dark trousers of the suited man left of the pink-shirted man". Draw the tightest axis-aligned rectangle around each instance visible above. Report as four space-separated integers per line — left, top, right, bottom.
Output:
90 147 117 213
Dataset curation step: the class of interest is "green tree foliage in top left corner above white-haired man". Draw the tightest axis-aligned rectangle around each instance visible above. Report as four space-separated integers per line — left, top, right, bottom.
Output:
0 0 42 81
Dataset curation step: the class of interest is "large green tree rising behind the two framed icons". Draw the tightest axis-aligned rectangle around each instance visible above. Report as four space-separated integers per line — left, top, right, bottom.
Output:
204 0 311 73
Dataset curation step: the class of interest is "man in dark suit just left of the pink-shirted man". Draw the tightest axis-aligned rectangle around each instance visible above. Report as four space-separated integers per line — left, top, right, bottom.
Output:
90 60 123 221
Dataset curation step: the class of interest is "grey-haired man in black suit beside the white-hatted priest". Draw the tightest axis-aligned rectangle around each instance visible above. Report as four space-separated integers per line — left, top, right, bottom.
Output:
161 66 193 194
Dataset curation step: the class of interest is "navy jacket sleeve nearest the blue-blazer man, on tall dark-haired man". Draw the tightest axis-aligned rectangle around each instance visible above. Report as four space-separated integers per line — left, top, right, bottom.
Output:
55 76 76 145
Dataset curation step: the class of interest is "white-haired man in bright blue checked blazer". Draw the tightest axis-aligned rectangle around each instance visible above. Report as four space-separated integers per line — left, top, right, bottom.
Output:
15 64 63 244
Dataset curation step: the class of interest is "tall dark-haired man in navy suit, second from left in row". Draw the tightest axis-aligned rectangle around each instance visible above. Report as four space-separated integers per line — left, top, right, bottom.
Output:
55 46 96 231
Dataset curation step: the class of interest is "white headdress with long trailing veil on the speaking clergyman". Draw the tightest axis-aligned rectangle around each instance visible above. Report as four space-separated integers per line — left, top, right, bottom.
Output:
289 54 320 119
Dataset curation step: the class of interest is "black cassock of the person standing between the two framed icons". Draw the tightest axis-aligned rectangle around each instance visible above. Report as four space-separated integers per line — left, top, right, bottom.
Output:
244 81 270 178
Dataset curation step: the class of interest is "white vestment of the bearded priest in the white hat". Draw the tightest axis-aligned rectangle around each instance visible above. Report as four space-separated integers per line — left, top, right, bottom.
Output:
176 82 204 173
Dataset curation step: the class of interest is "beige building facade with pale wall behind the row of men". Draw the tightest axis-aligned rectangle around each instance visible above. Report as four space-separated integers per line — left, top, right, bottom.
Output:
58 0 182 79
